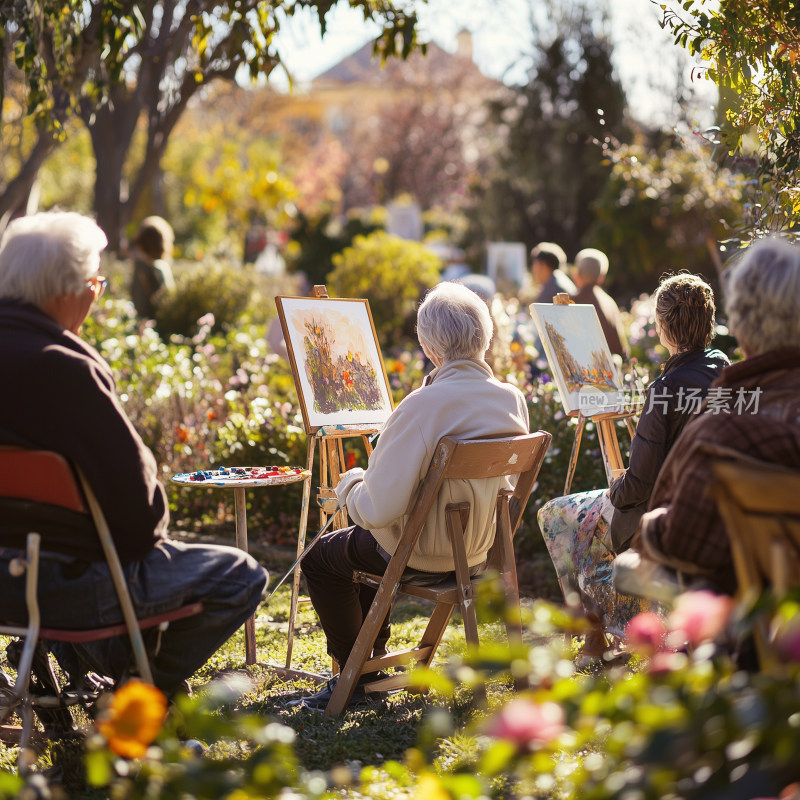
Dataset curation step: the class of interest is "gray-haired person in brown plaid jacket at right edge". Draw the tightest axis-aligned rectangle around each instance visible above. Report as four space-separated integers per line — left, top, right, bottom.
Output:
620 238 800 594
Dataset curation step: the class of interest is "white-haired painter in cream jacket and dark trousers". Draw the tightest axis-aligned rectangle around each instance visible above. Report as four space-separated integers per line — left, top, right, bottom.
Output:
295 282 529 708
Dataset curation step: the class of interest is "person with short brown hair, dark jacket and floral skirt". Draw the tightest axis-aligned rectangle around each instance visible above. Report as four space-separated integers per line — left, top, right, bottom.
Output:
539 273 729 655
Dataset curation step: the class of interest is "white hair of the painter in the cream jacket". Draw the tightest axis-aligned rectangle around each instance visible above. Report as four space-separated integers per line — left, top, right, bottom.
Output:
417 282 492 361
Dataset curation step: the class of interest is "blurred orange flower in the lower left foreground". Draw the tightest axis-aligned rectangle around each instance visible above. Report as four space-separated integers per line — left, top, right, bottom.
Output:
97 679 167 758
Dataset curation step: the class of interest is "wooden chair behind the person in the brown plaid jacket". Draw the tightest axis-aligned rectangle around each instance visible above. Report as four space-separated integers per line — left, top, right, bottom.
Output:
710 458 800 669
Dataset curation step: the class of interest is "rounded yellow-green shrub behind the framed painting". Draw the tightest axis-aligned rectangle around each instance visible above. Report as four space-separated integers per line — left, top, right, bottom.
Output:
328 231 441 349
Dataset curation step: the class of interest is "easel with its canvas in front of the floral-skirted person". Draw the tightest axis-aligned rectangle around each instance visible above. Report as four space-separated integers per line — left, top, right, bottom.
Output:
530 295 634 495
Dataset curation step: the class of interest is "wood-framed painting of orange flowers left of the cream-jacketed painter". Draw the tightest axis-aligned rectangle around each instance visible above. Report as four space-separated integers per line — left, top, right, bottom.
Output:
275 297 392 433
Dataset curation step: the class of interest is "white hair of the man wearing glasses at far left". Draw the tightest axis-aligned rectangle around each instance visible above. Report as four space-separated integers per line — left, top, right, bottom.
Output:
0 211 108 307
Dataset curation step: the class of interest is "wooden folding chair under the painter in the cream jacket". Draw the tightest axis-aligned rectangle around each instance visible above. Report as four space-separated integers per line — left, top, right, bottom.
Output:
325 431 551 716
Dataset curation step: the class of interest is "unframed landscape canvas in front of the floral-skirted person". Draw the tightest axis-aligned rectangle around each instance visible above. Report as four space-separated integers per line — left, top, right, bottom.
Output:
530 303 624 417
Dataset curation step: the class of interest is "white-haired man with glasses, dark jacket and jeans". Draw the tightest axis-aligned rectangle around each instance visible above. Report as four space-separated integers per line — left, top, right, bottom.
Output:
0 212 267 693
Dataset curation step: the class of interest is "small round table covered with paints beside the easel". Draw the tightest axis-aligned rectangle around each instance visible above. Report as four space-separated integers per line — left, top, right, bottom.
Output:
171 467 311 664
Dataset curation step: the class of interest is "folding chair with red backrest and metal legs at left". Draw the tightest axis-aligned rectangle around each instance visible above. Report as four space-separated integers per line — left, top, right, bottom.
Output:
0 447 203 768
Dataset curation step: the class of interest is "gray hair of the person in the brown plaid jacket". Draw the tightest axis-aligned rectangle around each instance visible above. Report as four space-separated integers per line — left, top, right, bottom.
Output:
723 237 800 356
